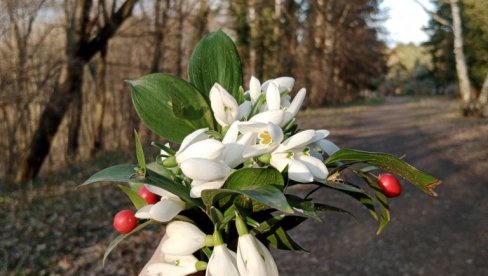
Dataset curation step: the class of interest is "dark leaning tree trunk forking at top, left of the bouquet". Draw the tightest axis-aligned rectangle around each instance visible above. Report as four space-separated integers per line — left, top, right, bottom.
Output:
15 0 137 182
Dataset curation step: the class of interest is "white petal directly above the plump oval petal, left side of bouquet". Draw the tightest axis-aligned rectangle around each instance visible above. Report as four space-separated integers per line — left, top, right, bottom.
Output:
176 139 224 164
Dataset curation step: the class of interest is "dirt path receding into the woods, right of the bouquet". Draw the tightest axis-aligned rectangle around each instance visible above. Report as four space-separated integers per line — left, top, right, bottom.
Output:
276 98 488 275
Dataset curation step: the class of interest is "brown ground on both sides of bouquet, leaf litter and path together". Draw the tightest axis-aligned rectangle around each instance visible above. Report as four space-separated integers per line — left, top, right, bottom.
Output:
0 98 488 275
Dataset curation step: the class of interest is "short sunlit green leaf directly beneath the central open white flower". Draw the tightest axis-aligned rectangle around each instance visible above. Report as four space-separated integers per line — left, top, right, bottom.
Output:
223 168 284 190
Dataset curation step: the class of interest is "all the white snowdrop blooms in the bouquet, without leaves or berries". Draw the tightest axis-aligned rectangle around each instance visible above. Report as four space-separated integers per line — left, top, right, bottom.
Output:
136 77 339 276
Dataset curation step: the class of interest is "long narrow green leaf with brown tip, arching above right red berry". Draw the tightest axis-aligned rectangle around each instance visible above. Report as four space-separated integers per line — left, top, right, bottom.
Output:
324 149 441 196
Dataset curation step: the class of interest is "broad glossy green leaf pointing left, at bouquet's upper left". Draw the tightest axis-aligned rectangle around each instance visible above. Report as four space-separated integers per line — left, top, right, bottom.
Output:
127 74 214 143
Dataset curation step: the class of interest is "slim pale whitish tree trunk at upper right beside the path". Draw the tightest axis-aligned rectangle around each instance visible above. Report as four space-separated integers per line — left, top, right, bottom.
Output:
450 0 474 116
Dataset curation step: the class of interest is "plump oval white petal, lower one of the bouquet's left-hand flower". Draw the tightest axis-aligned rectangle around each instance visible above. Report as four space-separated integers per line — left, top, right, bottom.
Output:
180 158 230 181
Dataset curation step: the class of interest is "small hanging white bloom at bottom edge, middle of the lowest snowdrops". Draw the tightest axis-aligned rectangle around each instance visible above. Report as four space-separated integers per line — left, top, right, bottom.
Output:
205 244 240 276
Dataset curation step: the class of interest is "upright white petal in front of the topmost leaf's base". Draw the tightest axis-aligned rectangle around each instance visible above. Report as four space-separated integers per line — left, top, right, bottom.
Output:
209 83 238 127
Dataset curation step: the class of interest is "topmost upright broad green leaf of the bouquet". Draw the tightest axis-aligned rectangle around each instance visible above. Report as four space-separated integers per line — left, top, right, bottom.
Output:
188 31 242 103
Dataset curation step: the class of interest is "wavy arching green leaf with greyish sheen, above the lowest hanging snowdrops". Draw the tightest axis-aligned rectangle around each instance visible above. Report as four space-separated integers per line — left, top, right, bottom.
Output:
202 185 293 213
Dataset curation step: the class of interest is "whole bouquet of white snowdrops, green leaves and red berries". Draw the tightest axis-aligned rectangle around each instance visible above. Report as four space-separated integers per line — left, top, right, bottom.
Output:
83 31 440 276
